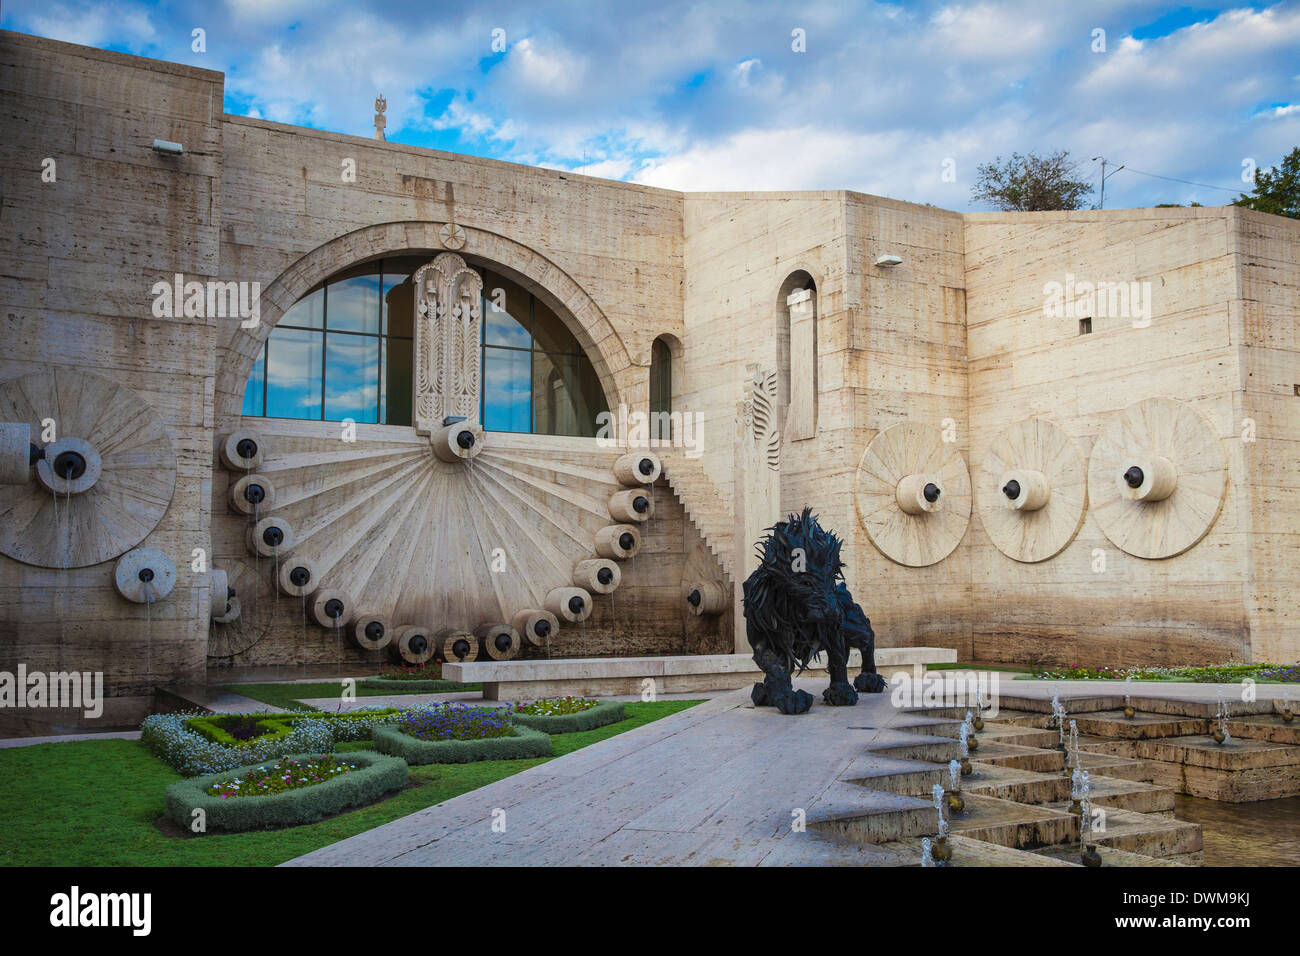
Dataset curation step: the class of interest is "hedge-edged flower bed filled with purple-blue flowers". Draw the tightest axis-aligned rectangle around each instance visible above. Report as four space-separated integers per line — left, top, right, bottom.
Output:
374 704 551 765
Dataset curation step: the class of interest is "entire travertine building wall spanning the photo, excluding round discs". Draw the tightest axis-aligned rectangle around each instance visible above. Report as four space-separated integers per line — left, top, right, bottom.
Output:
0 33 1300 733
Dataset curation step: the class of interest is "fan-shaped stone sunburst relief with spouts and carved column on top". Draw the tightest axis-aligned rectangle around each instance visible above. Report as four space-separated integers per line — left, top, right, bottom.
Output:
220 252 662 659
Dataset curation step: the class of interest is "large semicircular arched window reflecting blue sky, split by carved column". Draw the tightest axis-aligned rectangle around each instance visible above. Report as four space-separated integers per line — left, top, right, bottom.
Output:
243 256 608 436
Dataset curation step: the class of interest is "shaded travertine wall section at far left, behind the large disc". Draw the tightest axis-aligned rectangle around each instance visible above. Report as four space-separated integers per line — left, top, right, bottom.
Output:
0 33 222 723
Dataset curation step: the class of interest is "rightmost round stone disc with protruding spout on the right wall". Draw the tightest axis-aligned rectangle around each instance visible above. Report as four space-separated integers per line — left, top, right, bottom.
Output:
1088 398 1227 558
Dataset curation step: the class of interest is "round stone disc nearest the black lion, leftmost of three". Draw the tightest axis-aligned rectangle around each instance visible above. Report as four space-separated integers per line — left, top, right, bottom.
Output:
854 421 971 567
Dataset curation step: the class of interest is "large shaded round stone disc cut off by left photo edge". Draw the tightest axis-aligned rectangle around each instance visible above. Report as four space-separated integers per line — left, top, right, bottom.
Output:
0 368 176 568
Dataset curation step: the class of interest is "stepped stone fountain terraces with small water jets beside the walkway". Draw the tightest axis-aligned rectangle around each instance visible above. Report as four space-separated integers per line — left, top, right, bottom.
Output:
807 701 1222 866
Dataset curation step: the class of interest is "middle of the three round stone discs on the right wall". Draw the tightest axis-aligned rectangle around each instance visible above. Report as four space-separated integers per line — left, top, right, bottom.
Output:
975 419 1088 563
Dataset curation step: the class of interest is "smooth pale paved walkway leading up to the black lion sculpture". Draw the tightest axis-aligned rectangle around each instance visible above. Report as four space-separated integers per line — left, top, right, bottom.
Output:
286 679 950 866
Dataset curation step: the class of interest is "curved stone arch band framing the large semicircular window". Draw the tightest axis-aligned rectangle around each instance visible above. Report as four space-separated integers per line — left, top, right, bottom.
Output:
215 221 632 427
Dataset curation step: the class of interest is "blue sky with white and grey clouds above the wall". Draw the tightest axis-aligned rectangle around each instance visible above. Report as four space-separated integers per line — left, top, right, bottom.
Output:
0 0 1300 211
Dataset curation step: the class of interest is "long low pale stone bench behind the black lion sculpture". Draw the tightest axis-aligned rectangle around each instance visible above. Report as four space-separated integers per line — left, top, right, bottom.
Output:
442 648 957 700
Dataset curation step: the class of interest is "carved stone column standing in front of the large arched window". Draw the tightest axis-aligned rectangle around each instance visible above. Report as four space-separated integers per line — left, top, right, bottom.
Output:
413 252 484 434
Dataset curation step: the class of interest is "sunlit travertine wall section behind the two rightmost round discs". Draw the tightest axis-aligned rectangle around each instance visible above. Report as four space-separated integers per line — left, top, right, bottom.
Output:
966 209 1248 665
